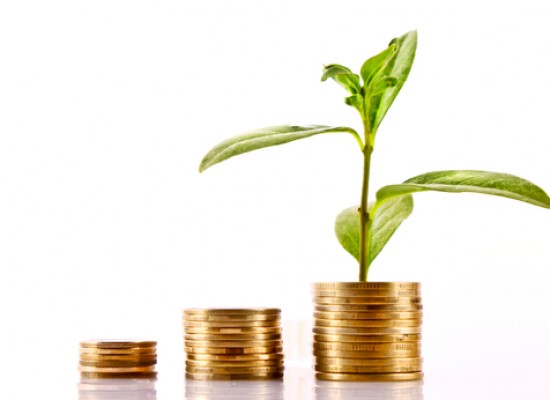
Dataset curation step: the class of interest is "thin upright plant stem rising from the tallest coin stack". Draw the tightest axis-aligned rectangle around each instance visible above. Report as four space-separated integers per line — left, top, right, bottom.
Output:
359 121 373 282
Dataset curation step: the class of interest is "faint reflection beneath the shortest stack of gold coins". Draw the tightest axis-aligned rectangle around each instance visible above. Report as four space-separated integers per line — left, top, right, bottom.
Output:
78 378 157 400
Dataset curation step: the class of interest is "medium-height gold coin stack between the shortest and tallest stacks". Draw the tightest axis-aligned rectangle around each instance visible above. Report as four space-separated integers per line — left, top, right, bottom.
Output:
184 308 284 380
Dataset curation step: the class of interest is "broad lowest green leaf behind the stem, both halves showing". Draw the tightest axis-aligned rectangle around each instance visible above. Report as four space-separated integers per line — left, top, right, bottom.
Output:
335 195 413 265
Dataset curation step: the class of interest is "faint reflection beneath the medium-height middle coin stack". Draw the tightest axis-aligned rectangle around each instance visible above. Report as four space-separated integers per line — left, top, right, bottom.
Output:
185 379 284 400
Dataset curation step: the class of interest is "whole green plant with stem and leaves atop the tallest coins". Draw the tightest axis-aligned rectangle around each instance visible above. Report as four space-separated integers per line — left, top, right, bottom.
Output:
199 31 550 281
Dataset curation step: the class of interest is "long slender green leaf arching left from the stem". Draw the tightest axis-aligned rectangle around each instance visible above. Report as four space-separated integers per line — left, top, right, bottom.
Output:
199 125 363 172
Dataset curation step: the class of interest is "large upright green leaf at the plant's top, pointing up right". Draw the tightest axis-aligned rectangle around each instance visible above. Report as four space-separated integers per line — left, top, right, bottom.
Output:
368 31 417 132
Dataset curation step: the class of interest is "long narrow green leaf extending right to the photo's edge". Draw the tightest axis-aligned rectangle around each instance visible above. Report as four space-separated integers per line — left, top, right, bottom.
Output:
376 171 550 208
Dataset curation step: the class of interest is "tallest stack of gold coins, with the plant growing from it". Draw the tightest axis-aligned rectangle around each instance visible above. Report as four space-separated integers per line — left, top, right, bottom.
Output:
313 282 423 382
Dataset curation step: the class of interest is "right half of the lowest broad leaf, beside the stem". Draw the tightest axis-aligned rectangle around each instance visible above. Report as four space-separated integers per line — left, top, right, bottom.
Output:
367 195 413 268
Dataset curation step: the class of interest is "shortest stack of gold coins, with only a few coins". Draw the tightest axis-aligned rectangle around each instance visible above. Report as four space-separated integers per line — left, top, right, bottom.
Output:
79 340 157 379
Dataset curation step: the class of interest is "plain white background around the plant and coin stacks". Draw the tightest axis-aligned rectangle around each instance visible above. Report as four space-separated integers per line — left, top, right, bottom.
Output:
0 0 550 400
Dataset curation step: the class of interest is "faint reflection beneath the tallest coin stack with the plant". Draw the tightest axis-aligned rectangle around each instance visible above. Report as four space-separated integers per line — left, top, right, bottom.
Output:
315 380 424 400
